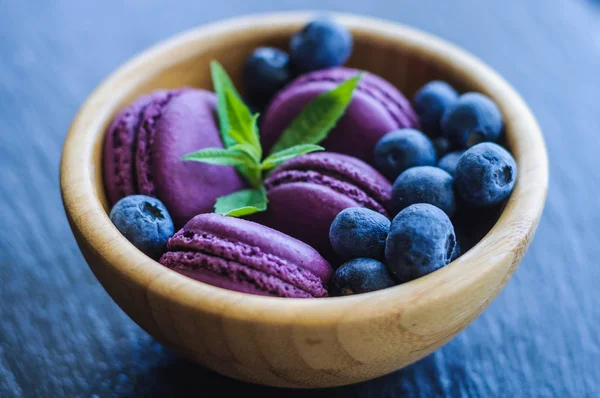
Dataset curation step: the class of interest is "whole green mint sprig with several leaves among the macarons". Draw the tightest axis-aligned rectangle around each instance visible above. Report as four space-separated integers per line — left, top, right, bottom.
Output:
182 61 362 217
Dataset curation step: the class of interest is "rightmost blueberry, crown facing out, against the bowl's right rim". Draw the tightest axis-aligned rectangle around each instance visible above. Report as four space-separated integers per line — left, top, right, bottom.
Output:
454 142 517 207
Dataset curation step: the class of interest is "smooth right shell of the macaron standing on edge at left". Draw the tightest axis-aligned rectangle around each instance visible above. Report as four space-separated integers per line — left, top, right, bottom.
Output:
145 89 246 228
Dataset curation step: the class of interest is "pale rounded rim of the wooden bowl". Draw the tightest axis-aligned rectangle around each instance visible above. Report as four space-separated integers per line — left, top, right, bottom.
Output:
60 11 548 325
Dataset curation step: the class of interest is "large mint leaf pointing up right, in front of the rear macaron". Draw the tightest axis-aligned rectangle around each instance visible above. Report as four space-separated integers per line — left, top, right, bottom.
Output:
271 72 362 153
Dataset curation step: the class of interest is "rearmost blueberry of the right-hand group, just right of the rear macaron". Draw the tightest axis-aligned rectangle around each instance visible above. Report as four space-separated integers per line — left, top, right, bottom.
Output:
413 80 458 136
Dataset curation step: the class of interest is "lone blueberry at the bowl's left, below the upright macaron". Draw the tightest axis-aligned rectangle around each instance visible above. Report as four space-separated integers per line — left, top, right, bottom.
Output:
110 195 175 259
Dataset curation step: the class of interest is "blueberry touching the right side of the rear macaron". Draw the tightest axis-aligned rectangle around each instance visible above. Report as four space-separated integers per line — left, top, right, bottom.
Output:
374 128 436 181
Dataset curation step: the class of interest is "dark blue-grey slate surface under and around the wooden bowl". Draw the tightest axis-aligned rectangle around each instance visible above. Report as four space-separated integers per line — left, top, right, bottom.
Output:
0 0 600 397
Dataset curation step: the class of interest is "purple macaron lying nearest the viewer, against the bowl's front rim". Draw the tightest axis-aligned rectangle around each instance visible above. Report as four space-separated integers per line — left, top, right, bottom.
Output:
160 213 333 298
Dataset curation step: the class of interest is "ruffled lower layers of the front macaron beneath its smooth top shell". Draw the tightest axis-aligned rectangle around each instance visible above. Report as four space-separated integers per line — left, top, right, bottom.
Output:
161 230 327 297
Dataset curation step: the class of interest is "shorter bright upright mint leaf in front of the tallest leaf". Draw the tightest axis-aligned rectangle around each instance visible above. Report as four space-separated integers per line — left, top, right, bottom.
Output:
225 89 262 159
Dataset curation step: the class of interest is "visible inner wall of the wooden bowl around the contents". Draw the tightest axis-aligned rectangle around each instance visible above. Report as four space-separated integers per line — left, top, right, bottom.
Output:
95 25 512 255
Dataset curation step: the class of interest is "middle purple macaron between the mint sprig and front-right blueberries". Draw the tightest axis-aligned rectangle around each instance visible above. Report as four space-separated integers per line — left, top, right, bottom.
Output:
249 152 393 267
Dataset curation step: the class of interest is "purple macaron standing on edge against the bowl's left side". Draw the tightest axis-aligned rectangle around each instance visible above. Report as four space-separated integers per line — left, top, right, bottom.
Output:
103 87 245 228
